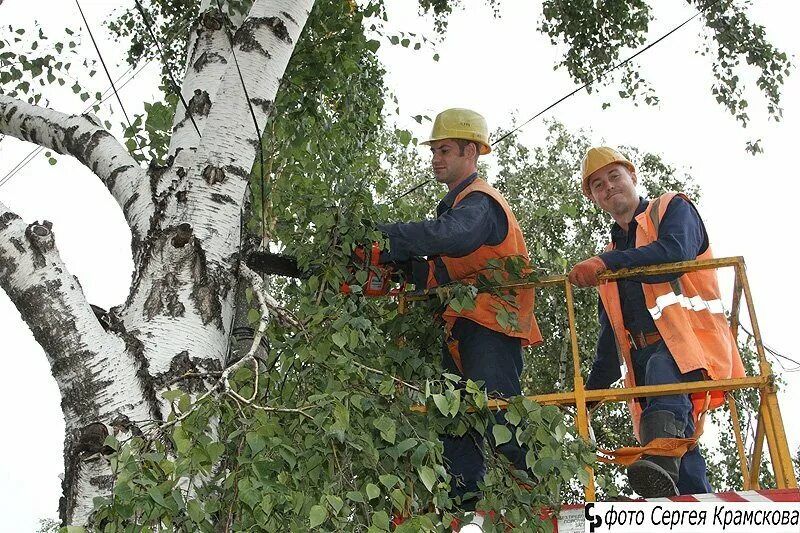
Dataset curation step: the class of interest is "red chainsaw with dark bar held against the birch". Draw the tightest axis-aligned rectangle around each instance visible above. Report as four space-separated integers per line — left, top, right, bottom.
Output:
246 242 406 298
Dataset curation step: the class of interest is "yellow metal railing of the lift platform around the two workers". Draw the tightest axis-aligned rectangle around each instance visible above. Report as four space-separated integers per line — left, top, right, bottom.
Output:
400 257 797 501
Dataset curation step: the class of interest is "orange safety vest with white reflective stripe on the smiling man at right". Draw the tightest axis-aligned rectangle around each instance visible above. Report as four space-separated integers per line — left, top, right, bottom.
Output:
598 192 745 438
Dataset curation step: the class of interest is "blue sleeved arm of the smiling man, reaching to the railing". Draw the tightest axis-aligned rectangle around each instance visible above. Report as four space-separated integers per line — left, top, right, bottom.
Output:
599 192 708 283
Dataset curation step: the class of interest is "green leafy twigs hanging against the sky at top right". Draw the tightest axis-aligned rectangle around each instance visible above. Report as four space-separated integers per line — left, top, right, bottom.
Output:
539 0 792 149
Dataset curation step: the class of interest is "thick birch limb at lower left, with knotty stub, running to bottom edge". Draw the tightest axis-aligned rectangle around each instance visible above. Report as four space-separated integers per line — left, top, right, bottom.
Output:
0 203 160 523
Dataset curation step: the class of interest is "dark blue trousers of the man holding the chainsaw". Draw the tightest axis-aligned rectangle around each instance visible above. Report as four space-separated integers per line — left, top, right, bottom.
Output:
442 318 526 504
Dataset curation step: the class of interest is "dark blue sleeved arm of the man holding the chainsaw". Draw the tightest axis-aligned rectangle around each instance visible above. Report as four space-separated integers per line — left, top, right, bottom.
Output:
378 192 508 262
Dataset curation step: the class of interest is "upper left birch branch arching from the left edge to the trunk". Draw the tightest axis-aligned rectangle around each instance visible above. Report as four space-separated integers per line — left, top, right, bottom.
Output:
0 94 151 232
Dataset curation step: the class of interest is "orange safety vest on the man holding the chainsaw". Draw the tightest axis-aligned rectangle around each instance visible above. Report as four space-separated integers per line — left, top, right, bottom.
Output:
428 178 542 346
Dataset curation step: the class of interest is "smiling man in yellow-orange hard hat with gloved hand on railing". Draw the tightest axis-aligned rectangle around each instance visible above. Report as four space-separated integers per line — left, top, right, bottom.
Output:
569 146 744 497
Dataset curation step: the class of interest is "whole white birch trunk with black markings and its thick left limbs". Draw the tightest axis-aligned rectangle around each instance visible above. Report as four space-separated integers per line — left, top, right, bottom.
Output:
0 0 314 525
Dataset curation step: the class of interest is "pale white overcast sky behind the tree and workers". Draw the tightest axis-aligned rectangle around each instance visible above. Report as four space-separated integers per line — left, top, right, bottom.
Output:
0 0 800 531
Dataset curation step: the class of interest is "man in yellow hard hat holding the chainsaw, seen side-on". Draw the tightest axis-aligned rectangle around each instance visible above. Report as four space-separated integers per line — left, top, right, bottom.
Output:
378 109 542 510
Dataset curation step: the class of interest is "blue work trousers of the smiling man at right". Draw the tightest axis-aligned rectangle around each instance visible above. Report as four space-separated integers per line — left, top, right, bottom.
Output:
631 341 713 494
